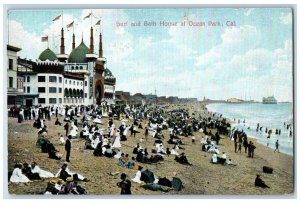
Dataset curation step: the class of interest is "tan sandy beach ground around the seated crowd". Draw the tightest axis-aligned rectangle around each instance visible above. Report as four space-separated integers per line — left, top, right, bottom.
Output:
8 104 294 195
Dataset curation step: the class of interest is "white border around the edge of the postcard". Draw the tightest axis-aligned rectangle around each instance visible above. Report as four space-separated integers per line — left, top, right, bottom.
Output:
0 0 300 202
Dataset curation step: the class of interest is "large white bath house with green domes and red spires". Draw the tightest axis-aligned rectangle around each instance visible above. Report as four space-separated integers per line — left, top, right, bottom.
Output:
18 28 116 106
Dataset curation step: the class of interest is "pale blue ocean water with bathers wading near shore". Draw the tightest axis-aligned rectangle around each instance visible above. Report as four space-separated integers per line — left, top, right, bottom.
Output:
207 103 294 155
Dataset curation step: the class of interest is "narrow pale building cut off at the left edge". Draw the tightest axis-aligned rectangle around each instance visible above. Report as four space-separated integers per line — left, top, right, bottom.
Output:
7 45 22 105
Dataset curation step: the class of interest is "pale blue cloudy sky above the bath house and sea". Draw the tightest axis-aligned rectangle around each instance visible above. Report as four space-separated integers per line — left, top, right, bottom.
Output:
8 8 293 101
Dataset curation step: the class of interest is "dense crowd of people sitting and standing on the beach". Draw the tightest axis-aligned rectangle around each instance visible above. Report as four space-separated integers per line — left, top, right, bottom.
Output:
10 101 276 194
